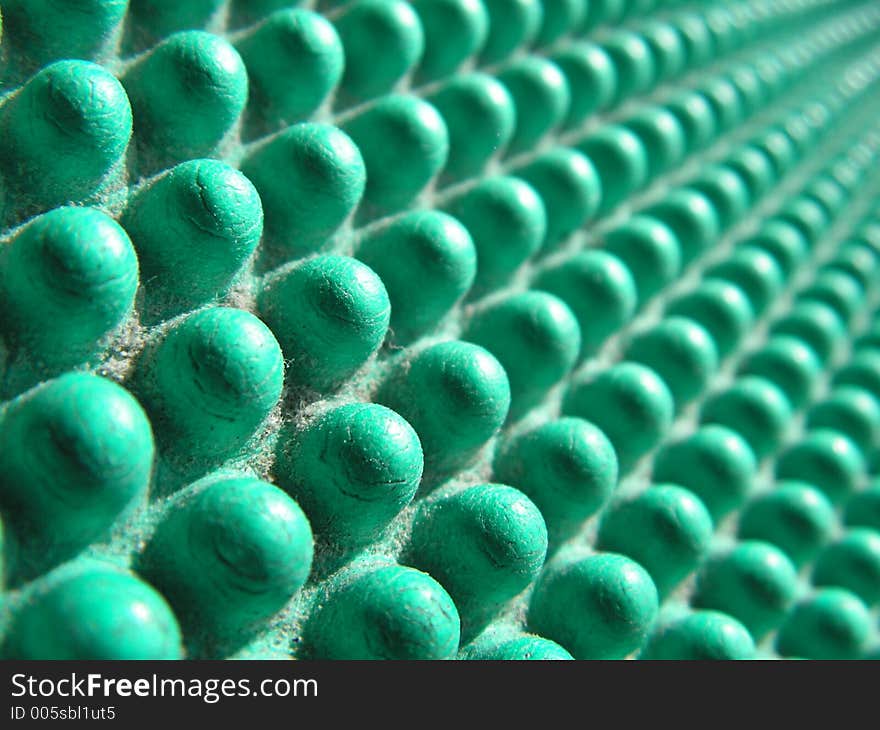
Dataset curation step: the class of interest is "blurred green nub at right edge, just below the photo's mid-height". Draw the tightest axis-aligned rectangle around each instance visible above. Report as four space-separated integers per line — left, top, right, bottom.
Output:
806 385 880 459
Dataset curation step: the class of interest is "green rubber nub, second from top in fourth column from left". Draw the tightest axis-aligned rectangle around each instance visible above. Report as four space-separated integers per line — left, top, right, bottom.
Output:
344 95 449 211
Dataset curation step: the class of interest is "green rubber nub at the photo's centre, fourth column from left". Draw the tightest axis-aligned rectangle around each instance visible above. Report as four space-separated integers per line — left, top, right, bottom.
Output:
377 341 510 475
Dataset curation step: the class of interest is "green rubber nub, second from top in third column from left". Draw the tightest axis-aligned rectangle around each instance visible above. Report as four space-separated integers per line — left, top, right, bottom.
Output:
242 124 366 259
